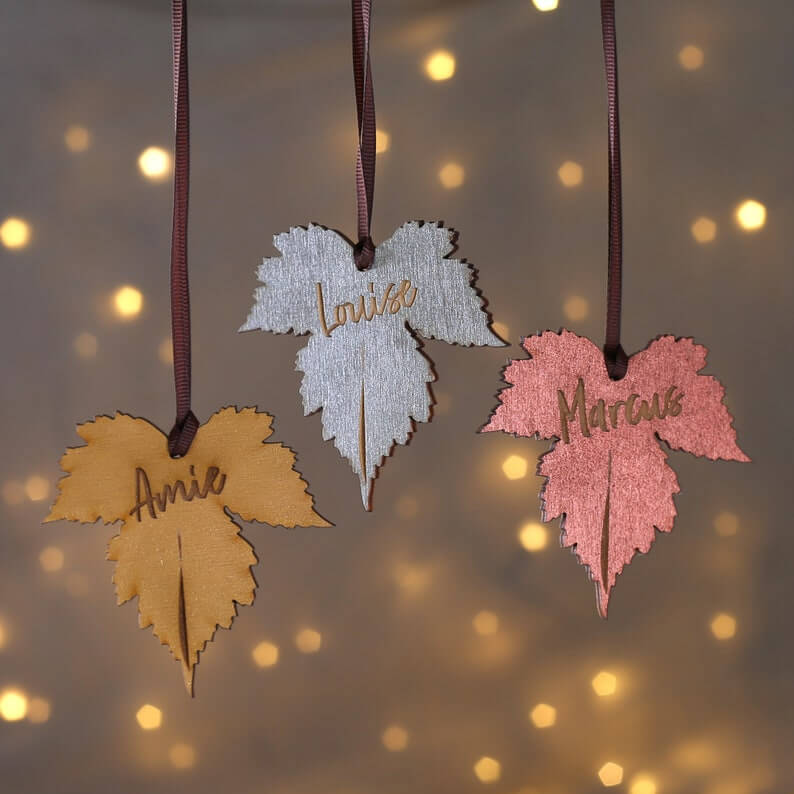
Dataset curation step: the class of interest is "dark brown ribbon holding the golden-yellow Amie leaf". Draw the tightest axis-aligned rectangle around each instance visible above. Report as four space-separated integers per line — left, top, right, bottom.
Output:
168 0 199 457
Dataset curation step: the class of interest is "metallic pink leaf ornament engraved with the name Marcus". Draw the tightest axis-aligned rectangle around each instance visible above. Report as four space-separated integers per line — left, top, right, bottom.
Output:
482 330 749 617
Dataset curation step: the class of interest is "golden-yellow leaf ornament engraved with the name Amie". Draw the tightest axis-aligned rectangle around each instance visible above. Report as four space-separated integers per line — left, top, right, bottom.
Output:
45 407 329 693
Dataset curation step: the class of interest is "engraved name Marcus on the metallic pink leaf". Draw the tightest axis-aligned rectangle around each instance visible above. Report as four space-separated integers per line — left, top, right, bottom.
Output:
557 378 684 444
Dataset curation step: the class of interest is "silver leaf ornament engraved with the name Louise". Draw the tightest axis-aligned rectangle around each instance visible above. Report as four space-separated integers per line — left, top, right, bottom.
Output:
240 222 504 510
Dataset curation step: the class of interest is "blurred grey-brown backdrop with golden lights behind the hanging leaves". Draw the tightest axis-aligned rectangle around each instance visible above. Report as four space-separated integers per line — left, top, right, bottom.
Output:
0 0 794 794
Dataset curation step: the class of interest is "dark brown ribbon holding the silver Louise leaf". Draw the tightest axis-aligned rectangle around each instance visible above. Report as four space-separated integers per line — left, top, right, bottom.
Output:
352 0 376 270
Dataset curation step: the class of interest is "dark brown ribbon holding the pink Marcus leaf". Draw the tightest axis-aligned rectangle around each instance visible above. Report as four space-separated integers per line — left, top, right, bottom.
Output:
601 0 629 380
